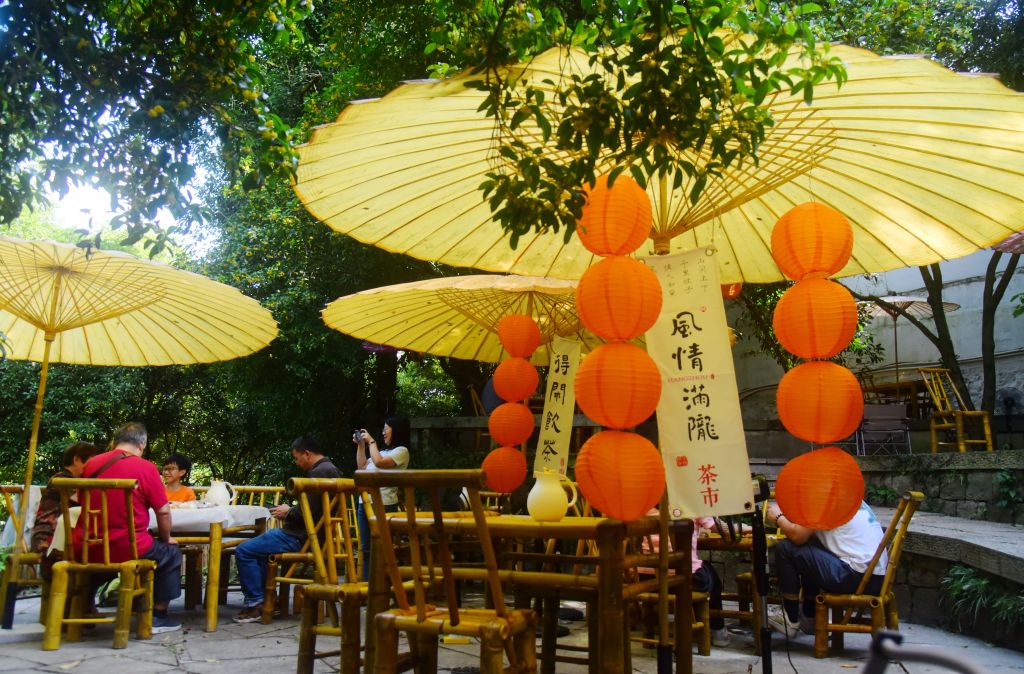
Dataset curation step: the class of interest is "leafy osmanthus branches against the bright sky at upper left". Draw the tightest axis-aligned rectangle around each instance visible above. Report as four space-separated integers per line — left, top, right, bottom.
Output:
0 0 312 252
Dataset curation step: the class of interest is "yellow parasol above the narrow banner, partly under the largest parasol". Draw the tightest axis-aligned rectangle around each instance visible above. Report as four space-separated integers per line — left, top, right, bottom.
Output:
324 275 604 366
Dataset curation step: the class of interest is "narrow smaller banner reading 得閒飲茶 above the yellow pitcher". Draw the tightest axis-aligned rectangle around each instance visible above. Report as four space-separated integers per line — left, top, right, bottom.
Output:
534 335 580 475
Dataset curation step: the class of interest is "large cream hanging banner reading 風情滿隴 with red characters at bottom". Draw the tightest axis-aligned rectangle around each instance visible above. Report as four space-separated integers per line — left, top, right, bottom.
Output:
643 248 754 519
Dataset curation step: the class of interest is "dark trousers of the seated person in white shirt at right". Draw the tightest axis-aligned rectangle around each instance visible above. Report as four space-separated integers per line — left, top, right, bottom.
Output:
775 538 885 616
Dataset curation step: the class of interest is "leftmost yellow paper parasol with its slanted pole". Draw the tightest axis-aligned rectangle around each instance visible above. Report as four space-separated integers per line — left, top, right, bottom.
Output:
0 237 278 540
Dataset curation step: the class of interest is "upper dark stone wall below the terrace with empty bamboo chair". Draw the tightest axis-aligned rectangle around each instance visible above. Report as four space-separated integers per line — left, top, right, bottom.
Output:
858 450 1024 524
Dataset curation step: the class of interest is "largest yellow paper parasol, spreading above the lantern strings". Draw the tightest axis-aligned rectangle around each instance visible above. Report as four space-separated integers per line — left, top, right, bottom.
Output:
295 45 1024 283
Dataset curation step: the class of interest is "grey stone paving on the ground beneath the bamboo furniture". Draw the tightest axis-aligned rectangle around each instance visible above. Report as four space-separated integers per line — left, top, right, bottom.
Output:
0 593 1024 674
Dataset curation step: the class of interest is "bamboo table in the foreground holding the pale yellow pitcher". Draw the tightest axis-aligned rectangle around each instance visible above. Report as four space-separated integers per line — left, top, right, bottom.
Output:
366 513 693 674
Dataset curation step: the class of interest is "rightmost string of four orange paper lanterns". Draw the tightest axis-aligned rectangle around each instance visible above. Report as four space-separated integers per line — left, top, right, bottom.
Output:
771 202 864 530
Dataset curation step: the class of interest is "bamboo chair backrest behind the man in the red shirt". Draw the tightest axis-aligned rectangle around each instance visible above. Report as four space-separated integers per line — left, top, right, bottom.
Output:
50 477 138 564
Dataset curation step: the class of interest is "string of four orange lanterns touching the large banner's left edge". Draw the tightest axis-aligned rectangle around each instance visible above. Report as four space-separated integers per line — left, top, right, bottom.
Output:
575 176 665 521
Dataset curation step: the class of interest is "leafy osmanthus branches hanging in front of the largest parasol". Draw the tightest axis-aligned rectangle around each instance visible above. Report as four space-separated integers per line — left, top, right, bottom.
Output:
432 0 845 248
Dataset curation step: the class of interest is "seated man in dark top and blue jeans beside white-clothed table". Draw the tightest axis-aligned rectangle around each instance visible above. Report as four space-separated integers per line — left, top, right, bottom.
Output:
233 435 341 623
